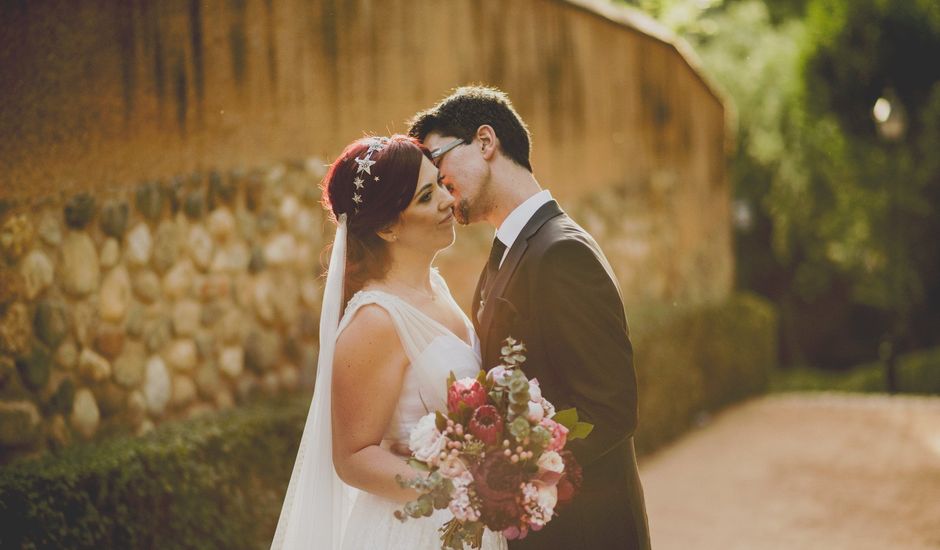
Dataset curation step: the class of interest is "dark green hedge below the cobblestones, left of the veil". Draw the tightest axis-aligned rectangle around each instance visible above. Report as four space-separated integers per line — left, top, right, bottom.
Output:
0 397 309 549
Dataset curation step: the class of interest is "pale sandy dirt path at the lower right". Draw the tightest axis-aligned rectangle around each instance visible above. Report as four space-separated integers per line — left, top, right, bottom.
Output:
640 394 940 550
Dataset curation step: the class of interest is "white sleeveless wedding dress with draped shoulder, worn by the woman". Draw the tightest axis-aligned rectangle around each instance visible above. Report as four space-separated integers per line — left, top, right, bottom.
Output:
337 271 507 550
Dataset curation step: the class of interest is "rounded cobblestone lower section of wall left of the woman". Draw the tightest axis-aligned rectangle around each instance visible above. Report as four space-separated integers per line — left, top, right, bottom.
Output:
0 161 329 458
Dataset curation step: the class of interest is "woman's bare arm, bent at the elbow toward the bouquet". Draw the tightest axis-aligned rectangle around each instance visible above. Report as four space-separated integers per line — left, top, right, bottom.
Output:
333 305 419 503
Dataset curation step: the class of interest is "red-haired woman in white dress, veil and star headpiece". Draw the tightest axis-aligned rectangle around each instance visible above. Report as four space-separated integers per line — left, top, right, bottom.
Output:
271 136 506 550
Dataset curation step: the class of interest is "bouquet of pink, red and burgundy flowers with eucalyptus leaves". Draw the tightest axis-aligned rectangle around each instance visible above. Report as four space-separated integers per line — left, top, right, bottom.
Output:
395 338 593 550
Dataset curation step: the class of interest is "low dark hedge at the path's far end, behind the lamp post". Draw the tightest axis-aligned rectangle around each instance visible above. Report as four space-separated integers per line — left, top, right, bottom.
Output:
772 348 940 395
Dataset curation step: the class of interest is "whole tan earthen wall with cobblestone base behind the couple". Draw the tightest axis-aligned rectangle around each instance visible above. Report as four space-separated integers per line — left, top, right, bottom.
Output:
0 0 733 462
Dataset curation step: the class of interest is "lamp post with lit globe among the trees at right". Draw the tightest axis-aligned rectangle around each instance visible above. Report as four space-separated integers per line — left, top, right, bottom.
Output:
872 89 907 393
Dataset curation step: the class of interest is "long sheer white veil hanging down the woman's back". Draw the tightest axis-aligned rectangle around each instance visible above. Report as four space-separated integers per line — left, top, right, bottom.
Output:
271 214 356 550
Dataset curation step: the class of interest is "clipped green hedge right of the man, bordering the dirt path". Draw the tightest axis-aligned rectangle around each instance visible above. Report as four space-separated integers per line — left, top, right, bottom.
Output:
628 293 777 454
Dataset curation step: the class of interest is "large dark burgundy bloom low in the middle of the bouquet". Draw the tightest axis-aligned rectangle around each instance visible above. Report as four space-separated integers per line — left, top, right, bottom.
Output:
473 454 525 531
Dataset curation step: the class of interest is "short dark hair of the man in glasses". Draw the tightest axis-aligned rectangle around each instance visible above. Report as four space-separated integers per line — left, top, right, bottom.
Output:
408 86 532 172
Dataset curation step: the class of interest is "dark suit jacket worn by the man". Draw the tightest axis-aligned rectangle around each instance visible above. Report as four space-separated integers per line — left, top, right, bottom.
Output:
473 201 650 550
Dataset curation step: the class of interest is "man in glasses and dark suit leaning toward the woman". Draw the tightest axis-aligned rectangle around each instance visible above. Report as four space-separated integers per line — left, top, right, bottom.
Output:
409 86 650 550
